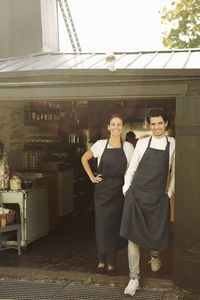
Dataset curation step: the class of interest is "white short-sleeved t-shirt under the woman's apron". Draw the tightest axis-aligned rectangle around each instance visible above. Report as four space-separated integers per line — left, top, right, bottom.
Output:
90 140 134 166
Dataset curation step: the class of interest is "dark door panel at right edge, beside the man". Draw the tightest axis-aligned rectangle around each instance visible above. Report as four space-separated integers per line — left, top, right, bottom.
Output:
173 97 200 291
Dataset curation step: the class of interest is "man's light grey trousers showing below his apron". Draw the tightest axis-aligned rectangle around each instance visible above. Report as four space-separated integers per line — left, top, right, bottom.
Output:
128 241 159 279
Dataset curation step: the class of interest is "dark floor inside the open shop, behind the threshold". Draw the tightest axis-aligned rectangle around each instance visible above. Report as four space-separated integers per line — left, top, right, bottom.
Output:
0 214 173 280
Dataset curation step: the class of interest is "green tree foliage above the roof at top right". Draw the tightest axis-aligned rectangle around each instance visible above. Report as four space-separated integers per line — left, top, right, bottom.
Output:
159 0 200 49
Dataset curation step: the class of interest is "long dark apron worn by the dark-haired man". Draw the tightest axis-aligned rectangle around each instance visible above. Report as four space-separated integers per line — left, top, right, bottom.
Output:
120 137 170 250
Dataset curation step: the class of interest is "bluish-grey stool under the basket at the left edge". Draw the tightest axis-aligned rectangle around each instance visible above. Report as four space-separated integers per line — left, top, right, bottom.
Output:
0 224 21 255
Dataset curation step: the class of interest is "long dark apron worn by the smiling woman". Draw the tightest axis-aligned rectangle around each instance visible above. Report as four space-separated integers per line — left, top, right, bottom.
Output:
94 141 127 253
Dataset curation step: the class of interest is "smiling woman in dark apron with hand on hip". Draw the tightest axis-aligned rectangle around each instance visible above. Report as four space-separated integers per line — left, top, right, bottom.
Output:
82 115 134 277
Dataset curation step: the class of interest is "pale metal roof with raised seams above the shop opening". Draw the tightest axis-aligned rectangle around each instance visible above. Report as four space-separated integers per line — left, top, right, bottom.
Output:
0 48 200 72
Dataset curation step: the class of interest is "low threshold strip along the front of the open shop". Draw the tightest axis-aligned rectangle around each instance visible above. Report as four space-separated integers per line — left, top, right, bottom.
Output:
0 267 200 300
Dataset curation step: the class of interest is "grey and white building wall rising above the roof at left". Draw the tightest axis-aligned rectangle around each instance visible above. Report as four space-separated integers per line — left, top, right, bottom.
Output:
0 0 59 58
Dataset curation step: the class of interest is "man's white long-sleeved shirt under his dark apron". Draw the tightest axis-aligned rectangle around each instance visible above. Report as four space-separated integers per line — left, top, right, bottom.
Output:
123 136 175 198
